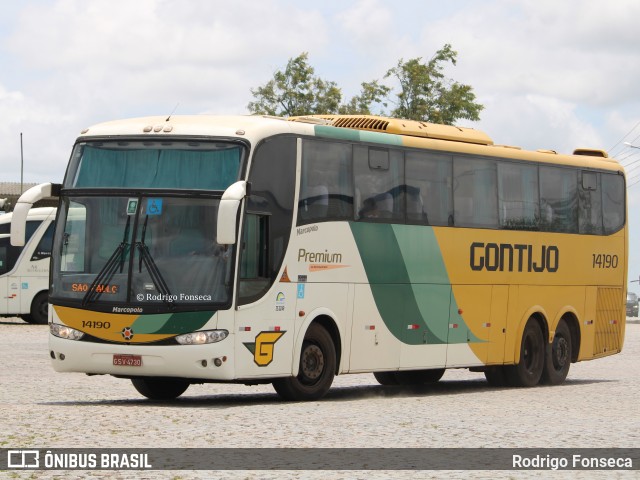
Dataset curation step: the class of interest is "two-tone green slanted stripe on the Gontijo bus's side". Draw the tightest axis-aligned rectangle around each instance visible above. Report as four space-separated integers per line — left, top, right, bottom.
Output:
349 222 480 345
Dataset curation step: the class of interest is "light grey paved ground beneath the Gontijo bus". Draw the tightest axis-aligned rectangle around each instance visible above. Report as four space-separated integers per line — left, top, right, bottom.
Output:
0 319 640 479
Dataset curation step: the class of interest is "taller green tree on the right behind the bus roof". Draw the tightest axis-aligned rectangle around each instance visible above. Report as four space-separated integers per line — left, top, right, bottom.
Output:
385 44 484 125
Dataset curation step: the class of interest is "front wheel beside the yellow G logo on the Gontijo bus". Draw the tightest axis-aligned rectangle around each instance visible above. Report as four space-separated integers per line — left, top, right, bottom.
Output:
273 323 336 401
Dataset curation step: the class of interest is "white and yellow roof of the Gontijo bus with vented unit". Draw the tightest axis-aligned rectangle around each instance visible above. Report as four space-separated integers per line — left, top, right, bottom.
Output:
78 115 623 171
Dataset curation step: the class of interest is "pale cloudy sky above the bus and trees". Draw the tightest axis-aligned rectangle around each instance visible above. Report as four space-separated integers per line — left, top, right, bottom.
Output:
0 0 640 292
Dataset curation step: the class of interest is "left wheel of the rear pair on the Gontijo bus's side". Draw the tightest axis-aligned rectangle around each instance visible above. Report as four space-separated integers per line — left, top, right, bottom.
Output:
505 318 546 387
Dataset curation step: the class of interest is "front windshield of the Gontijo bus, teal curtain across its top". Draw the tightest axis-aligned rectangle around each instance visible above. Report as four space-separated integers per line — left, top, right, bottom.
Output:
51 141 243 313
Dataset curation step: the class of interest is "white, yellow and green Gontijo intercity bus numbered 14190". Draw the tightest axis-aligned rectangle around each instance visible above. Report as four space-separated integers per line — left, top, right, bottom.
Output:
12 116 628 400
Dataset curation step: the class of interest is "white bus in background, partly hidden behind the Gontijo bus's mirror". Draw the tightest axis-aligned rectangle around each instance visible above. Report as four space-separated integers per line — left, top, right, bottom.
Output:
0 207 56 324
